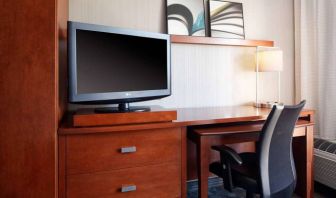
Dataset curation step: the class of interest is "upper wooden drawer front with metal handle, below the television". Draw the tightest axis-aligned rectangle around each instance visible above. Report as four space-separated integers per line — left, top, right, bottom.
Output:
66 128 181 175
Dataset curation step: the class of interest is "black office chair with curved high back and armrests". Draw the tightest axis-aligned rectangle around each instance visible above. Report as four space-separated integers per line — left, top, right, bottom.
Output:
209 101 306 198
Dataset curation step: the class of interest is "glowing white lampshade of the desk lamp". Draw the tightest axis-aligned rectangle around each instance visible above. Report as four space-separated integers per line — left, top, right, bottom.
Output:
257 50 283 72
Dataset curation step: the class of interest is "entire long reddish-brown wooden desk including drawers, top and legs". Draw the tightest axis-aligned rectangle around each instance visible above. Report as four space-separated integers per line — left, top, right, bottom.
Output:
58 106 314 198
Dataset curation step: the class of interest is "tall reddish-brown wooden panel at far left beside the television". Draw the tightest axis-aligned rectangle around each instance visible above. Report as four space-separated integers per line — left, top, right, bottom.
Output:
0 0 67 198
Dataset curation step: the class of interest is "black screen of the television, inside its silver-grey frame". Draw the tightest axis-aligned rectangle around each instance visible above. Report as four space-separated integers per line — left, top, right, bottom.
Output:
76 30 167 94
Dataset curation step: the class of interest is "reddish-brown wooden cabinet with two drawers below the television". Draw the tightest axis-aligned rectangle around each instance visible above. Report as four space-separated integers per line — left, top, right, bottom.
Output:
59 127 182 198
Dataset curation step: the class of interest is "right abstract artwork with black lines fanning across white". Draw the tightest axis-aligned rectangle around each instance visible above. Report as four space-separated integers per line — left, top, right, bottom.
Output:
209 0 245 39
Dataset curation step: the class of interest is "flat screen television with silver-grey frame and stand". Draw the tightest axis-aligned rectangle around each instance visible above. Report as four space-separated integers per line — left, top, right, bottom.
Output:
68 21 171 112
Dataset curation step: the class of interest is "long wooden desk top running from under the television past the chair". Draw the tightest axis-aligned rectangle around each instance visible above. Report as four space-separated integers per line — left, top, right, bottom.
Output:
58 106 314 135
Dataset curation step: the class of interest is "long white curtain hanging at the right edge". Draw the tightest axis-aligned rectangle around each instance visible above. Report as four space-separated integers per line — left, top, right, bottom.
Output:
294 0 336 139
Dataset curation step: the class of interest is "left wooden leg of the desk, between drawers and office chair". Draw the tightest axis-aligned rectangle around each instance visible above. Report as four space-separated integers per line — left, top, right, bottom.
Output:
197 136 210 198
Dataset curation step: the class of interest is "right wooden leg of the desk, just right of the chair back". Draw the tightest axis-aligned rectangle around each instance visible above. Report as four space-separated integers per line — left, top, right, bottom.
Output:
293 126 314 198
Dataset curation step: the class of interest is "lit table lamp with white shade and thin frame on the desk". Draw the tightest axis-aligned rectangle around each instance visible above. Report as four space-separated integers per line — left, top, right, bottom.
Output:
255 48 283 108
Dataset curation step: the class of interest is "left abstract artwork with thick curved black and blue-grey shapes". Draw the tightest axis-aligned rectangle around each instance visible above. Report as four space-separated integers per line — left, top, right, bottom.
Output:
167 0 205 36
